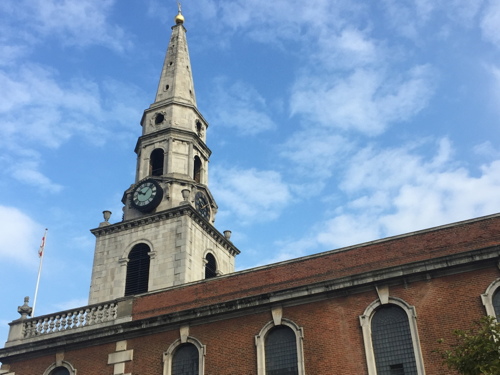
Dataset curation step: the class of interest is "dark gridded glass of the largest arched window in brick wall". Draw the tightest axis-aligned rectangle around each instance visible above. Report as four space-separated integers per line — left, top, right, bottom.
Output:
372 305 417 375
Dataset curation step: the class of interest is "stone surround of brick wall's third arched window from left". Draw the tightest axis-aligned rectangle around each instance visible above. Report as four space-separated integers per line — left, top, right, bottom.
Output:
255 318 305 375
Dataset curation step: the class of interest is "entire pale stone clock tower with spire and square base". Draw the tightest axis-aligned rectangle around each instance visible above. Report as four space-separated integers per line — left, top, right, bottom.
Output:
89 6 239 304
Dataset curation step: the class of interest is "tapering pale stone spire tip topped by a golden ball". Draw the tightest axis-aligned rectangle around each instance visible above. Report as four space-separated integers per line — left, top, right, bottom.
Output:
151 5 196 107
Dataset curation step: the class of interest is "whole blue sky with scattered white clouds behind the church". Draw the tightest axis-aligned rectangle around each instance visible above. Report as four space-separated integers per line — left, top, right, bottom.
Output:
0 0 500 342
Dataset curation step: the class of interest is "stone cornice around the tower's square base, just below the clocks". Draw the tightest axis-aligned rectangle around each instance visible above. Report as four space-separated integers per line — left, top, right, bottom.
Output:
90 204 240 256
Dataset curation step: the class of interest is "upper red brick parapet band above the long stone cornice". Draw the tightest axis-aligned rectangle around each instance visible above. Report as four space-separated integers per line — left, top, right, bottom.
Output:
133 215 500 319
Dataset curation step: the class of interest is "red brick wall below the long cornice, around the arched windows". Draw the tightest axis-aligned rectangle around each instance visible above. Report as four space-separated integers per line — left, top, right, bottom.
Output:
4 267 500 375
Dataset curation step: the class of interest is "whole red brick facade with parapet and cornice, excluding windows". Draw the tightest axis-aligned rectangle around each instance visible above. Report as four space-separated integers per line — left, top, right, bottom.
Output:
0 215 500 375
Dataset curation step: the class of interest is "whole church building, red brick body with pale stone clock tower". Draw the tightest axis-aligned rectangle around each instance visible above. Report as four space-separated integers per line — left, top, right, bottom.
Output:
0 11 500 375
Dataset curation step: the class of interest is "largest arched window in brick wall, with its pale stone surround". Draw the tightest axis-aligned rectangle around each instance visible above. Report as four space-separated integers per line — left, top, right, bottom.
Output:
359 296 424 375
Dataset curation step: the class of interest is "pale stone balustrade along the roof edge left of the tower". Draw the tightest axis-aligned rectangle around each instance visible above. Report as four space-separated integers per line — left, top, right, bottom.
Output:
22 302 117 338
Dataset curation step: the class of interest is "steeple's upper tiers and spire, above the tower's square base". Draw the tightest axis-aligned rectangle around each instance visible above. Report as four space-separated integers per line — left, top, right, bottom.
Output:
123 6 217 222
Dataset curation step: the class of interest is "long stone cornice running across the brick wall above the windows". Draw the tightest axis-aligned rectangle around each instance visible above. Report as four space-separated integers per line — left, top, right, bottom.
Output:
0 246 500 360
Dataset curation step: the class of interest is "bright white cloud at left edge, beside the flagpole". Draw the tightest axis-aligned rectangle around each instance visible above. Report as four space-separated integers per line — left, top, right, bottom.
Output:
0 206 43 269
